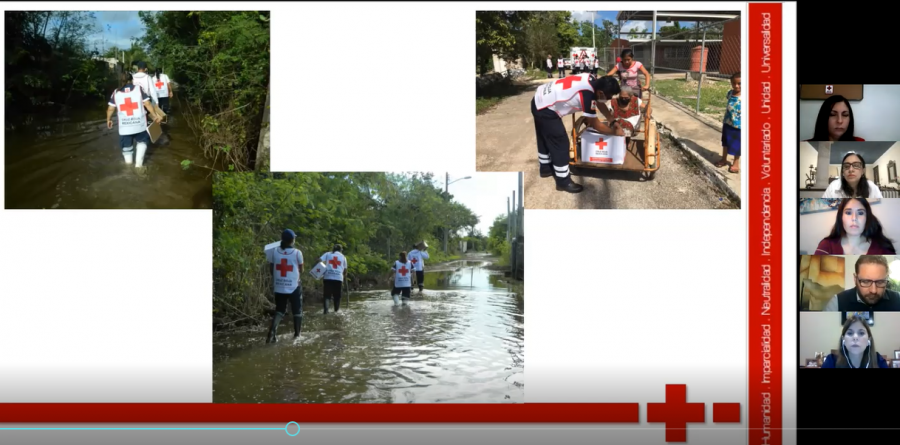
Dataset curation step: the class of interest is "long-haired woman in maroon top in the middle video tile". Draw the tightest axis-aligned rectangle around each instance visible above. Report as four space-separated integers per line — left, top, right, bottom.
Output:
815 198 897 255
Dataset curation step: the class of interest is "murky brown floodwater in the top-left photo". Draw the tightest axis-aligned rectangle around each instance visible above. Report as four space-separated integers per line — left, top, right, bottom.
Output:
5 102 212 209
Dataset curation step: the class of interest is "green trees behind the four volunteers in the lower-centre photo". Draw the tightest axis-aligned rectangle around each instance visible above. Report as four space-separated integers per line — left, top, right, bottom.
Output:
213 172 488 326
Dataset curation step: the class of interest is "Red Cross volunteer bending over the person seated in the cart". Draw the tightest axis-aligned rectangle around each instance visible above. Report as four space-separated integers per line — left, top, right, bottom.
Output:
531 74 625 193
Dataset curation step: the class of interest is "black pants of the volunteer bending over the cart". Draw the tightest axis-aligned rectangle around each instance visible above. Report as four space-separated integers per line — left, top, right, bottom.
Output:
531 99 572 186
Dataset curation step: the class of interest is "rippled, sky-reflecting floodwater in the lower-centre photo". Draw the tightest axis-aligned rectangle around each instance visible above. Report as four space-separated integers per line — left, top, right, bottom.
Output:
213 261 525 403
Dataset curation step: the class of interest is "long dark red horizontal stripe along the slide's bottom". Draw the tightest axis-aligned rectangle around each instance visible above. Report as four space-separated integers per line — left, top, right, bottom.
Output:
0 403 638 423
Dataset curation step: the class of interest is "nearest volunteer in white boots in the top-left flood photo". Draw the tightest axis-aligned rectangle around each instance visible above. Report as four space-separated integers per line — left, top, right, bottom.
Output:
106 74 162 168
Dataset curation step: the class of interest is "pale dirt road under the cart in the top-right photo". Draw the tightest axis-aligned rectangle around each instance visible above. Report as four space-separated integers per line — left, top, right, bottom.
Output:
475 79 738 209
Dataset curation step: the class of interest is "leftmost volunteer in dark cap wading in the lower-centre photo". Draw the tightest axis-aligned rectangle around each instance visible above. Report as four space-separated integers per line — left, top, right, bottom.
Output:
266 229 303 343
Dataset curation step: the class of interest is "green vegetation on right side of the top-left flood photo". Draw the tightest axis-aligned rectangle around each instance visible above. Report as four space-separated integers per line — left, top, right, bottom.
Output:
139 11 270 171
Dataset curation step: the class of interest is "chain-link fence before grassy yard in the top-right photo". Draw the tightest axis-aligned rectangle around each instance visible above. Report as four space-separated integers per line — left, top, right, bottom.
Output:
598 17 742 121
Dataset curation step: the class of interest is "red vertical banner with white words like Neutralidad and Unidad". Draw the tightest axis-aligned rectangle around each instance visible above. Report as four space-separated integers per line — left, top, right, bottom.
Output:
741 3 780 445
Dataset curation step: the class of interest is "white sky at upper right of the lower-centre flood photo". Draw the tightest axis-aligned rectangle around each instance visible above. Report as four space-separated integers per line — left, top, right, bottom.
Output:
432 172 519 235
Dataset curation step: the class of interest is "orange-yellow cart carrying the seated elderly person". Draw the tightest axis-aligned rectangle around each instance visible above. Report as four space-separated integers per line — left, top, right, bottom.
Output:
569 90 660 179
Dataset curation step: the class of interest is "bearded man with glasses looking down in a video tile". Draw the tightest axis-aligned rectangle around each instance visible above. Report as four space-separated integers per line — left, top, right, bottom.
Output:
824 255 900 312
